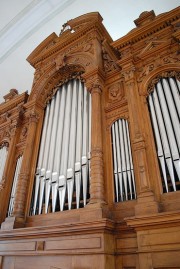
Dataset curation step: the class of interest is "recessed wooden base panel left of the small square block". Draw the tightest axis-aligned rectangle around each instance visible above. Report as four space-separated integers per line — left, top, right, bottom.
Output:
0 242 36 252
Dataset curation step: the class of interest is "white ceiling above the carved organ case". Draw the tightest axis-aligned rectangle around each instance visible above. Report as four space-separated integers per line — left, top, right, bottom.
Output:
0 0 179 102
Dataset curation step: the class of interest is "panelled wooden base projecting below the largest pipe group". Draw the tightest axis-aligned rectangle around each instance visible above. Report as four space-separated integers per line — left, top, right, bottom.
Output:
0 218 115 269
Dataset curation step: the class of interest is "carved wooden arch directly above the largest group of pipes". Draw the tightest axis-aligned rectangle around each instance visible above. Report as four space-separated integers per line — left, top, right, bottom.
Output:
30 50 95 103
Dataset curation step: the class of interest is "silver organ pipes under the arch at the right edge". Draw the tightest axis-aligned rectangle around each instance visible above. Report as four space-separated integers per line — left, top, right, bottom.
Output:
148 77 180 192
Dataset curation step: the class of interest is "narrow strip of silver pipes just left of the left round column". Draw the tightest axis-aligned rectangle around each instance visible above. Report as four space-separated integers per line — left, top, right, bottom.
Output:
7 156 23 216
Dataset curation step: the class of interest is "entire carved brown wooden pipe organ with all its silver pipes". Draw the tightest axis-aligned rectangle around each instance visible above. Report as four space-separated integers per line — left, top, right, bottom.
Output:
0 8 180 269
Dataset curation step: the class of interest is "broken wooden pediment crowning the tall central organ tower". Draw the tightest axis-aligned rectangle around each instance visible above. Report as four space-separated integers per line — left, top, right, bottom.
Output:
27 12 112 67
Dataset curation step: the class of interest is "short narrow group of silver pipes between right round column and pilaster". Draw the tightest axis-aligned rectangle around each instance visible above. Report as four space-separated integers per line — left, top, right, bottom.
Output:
111 119 136 202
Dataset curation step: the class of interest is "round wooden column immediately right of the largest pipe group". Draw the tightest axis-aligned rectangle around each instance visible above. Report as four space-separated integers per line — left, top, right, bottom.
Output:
90 78 105 204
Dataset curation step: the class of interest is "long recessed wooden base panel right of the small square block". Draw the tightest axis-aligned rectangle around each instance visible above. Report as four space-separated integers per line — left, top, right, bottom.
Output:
45 237 101 250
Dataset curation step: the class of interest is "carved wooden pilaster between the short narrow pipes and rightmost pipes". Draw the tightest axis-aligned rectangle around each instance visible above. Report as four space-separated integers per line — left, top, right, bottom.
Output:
124 65 158 215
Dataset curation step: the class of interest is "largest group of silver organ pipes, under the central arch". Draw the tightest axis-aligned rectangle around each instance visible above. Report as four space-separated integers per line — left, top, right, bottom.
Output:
30 79 91 215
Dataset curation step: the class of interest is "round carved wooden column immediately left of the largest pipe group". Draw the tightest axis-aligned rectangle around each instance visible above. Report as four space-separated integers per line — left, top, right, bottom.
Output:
13 111 38 218
